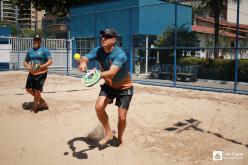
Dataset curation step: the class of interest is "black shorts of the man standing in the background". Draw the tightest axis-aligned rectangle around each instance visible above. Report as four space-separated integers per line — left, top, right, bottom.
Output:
26 73 47 91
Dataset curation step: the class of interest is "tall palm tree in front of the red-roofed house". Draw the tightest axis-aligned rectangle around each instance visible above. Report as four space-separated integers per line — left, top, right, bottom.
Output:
200 0 241 58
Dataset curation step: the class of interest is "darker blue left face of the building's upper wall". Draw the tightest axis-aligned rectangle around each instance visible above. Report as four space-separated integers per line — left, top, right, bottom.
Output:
70 0 138 47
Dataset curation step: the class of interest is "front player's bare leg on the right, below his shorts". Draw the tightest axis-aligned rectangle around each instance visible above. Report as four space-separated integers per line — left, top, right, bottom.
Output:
118 107 128 146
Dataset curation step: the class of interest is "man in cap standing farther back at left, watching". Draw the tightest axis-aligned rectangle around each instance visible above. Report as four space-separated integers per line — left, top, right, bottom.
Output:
23 35 52 113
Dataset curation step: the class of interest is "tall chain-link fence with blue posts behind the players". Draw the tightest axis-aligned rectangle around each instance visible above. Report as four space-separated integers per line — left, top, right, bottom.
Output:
0 0 248 94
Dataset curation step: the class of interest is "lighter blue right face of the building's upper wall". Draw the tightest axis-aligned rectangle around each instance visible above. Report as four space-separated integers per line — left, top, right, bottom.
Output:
139 0 192 35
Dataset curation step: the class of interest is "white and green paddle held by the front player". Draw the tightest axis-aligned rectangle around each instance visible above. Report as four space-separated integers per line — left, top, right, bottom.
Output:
82 70 101 87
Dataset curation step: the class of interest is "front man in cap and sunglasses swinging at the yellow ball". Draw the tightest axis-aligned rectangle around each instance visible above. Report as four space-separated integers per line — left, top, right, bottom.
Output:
79 29 133 146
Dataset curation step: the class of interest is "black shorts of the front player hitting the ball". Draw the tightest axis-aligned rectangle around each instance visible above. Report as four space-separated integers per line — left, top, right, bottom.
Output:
99 84 133 110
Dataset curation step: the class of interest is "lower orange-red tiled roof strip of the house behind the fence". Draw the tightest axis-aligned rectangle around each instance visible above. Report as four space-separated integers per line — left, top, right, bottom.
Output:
192 25 245 38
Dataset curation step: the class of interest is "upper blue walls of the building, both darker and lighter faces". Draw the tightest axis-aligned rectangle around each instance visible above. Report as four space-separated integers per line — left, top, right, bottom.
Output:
70 0 192 67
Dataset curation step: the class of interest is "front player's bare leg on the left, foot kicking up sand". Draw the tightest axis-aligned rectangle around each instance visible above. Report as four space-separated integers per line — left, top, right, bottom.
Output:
95 96 113 145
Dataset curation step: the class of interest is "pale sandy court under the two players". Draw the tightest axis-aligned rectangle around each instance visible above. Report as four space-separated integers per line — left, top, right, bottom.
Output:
0 71 248 165
